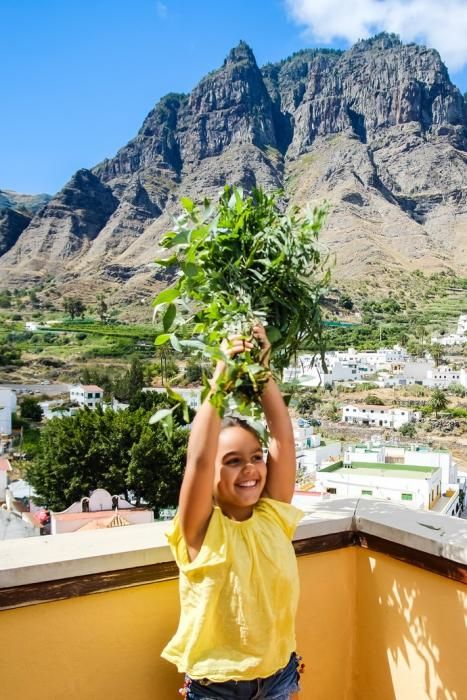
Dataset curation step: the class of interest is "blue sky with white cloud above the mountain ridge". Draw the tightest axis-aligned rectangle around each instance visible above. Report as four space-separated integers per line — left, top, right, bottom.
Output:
0 0 467 194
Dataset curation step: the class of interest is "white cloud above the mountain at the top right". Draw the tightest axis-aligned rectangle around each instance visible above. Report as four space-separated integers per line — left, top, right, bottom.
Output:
285 0 467 71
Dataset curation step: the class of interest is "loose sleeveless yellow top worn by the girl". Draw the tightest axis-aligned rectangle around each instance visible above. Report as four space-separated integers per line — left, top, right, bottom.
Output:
162 498 303 682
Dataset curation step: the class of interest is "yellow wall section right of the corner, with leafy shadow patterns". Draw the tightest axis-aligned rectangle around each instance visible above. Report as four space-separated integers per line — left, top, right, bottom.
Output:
354 549 467 700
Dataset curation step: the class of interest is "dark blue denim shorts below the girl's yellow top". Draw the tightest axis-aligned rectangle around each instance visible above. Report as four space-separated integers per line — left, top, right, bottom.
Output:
185 652 300 700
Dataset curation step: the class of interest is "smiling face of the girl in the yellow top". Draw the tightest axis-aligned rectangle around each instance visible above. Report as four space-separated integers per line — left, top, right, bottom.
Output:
214 426 267 520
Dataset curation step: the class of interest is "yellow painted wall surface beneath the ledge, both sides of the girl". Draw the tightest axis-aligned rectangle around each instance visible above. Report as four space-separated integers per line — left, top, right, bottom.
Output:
0 548 467 700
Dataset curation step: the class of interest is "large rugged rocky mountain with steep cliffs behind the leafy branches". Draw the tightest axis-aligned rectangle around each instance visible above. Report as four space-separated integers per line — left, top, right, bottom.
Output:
0 34 467 298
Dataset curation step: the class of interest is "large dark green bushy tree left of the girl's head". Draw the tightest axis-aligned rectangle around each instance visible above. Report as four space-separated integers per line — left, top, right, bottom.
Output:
26 396 188 510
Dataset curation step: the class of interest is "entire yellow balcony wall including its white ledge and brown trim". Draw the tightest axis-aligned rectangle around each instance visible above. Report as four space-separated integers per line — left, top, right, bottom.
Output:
0 500 467 700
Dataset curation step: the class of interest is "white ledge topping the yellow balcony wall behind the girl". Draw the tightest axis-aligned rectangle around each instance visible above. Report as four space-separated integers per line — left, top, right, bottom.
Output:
0 498 467 588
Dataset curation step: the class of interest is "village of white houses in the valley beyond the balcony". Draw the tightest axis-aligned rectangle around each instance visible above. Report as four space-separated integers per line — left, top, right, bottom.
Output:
0 315 467 539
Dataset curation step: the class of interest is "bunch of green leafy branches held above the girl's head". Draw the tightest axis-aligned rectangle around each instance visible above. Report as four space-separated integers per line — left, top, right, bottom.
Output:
154 186 330 420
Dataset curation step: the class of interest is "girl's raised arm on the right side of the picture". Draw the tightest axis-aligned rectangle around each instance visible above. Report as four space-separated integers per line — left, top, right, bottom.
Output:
253 326 297 503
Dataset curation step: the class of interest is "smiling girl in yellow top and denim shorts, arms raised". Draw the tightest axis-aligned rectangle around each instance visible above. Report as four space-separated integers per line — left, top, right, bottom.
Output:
162 326 303 700
